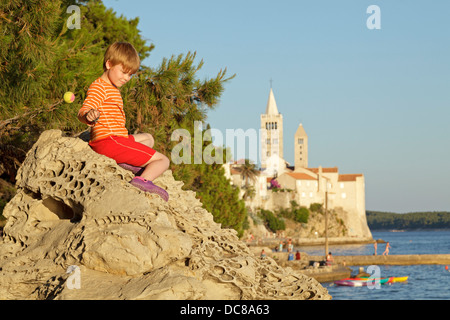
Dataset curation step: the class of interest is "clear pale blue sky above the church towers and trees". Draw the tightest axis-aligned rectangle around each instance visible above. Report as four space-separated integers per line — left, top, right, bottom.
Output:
103 0 450 213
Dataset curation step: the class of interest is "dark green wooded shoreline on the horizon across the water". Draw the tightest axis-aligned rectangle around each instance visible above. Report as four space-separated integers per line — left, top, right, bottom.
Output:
366 211 450 230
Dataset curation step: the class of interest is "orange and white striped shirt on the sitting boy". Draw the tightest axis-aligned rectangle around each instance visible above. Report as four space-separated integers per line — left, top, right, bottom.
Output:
78 78 128 141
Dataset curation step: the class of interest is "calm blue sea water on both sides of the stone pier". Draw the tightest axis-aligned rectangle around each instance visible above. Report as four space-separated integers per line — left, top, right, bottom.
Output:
300 230 450 300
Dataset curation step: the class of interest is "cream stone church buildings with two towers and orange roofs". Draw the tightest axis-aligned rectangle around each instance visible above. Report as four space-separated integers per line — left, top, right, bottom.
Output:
226 88 371 237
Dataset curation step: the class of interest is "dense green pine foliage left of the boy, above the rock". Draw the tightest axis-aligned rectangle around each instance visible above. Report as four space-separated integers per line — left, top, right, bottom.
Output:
0 0 153 136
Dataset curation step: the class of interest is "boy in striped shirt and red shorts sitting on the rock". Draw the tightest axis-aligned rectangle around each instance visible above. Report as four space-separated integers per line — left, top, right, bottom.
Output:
78 42 170 201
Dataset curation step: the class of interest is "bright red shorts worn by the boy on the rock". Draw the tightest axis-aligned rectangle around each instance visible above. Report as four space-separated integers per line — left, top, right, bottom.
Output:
89 135 156 167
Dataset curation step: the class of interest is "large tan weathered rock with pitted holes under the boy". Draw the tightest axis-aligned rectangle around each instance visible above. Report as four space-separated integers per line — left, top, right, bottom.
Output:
0 130 331 299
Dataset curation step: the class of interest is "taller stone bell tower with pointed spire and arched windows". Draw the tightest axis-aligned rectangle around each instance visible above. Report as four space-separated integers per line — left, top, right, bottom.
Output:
261 88 283 169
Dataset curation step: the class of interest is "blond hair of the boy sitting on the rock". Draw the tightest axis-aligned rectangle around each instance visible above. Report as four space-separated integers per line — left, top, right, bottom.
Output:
103 42 141 73
